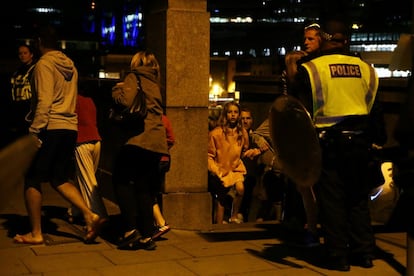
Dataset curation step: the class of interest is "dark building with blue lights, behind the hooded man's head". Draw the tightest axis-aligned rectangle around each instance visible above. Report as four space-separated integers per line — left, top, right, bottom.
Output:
0 0 147 53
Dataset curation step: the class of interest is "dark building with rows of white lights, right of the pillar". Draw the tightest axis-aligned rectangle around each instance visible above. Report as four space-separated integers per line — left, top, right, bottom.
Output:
208 0 413 80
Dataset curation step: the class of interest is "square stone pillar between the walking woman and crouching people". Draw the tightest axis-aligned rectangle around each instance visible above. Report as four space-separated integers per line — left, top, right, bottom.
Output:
146 0 212 230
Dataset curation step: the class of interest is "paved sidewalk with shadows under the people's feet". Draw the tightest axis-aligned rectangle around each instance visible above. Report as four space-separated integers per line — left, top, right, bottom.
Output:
0 182 406 276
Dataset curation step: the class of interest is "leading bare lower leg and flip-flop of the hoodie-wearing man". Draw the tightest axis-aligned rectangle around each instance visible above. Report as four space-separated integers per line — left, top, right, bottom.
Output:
14 187 43 244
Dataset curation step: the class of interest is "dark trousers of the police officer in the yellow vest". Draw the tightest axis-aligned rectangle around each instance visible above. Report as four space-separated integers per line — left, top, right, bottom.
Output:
315 130 375 257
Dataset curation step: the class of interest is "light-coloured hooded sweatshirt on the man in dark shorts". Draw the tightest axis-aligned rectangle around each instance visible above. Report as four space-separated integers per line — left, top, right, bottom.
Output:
29 51 78 133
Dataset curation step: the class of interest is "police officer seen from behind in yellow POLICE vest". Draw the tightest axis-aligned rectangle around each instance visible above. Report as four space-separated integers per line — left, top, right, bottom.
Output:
288 20 386 271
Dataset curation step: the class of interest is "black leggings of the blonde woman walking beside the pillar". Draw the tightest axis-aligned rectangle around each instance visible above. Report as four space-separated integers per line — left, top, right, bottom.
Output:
113 145 160 238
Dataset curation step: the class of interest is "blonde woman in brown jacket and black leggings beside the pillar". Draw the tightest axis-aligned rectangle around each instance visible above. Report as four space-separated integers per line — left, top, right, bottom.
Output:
112 51 168 250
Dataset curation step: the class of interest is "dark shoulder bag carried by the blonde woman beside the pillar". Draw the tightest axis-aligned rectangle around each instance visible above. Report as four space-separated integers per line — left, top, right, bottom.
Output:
109 72 148 125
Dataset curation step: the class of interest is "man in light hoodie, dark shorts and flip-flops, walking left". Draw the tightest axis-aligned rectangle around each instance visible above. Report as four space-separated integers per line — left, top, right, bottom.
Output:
14 26 104 244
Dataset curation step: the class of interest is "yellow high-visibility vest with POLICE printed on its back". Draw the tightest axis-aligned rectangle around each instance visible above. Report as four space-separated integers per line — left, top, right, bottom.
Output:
302 54 378 128
